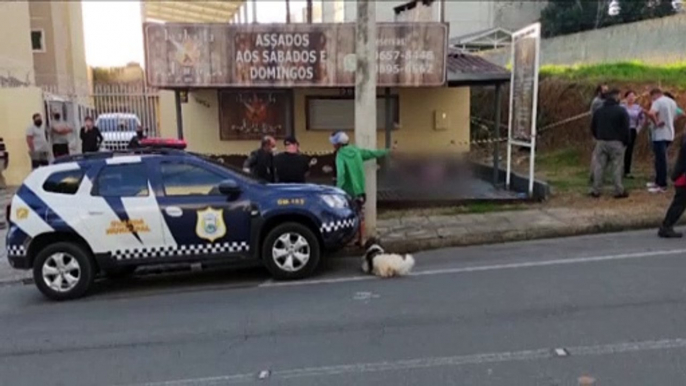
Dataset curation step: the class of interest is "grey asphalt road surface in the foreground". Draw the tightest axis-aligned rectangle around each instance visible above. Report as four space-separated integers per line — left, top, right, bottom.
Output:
0 231 686 386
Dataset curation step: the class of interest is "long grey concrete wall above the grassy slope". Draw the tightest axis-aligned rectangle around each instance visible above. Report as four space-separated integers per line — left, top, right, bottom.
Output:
481 14 686 66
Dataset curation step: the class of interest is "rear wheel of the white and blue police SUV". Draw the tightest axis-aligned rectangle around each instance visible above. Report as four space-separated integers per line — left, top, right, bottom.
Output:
33 242 95 300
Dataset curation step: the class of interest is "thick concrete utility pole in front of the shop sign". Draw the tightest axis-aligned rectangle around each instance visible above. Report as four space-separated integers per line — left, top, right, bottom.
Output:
355 0 377 239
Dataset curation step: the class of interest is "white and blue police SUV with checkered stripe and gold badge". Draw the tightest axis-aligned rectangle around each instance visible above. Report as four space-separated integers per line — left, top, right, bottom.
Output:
6 149 359 300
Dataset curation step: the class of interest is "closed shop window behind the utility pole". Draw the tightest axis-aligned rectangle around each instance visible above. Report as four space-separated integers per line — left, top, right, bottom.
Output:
305 95 400 131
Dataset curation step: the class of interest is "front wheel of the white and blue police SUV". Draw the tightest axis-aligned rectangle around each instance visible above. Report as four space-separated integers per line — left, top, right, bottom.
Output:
262 222 321 280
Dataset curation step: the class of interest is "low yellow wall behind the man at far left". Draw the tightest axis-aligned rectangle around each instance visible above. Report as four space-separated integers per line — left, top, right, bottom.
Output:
0 87 43 186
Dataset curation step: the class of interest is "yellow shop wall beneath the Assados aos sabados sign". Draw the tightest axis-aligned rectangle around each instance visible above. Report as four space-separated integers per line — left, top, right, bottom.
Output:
159 87 470 154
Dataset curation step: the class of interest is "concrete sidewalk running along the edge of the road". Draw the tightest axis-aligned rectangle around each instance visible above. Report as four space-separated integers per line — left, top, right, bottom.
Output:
0 188 676 284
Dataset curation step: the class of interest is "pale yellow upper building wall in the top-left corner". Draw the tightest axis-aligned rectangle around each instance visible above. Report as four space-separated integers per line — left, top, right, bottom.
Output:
0 1 35 84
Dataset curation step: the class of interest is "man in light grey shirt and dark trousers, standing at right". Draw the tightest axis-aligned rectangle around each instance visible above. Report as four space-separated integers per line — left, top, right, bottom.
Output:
647 88 677 193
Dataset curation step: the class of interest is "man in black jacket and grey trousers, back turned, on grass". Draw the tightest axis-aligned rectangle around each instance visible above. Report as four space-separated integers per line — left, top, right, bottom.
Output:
591 89 630 198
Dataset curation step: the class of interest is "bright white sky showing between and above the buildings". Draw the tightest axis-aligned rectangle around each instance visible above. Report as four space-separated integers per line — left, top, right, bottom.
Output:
81 0 305 67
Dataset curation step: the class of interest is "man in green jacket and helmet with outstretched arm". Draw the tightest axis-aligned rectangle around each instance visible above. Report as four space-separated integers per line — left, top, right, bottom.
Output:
329 131 390 245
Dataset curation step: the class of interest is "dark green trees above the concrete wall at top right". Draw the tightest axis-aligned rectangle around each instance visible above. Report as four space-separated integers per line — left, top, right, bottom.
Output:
541 0 676 37
